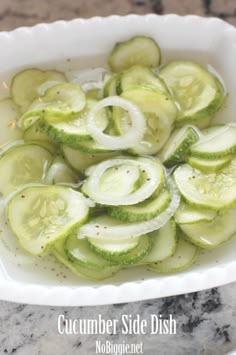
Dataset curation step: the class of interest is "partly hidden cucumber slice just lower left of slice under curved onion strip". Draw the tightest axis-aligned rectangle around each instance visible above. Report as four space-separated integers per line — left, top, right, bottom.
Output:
65 234 115 270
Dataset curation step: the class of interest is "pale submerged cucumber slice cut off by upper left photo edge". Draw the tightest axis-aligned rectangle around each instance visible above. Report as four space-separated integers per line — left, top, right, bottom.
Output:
0 99 22 146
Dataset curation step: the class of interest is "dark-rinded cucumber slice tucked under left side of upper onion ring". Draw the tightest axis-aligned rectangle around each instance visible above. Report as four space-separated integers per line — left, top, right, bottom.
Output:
42 100 109 148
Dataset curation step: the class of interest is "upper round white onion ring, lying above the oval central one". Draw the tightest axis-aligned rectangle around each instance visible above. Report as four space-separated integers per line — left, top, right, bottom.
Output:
87 96 146 150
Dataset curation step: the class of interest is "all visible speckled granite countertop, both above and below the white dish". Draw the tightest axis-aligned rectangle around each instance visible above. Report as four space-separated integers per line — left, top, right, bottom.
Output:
0 0 236 355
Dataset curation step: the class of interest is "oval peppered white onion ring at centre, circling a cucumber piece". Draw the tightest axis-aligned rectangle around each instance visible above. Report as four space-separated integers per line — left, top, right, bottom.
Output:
86 159 163 206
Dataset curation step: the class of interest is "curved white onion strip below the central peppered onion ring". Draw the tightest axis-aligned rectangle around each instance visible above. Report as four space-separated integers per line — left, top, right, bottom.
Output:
78 179 180 241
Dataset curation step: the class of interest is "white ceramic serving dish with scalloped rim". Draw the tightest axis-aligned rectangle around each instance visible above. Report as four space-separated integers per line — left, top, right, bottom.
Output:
0 15 236 306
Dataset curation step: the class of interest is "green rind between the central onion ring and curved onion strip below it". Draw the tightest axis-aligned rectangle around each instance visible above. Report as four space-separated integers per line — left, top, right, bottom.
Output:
107 189 171 222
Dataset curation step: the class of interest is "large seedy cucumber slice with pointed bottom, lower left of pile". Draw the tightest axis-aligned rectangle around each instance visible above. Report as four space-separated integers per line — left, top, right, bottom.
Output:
6 185 89 255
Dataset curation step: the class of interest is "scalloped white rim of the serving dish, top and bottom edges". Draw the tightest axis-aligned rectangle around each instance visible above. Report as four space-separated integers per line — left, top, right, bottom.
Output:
0 14 236 306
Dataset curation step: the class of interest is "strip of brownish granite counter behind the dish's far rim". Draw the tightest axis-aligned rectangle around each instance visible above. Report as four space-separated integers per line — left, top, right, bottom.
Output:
0 0 236 30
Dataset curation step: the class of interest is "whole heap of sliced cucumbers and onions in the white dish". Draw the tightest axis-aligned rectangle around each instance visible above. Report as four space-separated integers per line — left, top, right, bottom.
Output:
0 36 236 281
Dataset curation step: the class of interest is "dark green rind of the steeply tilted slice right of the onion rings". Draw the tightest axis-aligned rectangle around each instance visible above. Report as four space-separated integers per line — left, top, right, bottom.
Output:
160 130 199 168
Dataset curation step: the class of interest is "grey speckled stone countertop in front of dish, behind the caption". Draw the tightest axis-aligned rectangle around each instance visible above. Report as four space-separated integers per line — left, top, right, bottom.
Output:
0 283 236 355
